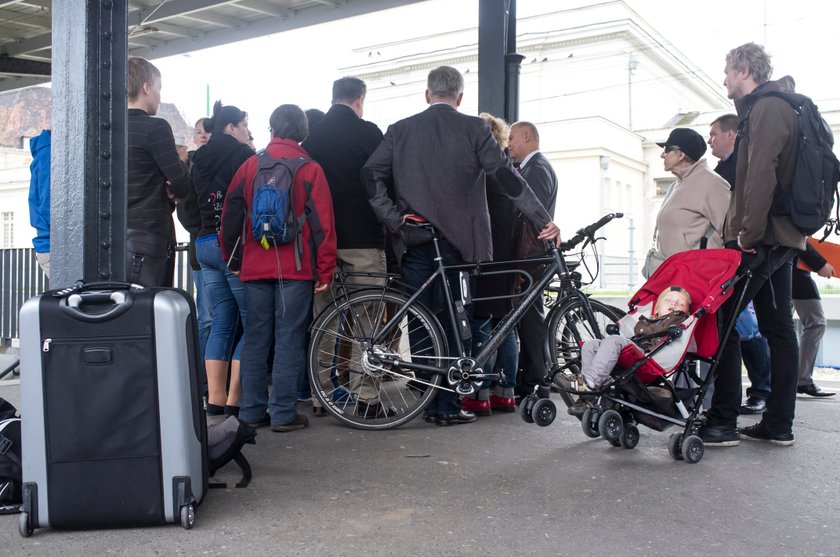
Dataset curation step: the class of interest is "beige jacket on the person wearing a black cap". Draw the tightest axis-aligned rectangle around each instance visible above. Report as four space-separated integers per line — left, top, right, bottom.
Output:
656 159 729 257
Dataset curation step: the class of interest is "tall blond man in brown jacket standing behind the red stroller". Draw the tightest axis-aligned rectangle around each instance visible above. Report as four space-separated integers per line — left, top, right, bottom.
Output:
700 43 820 446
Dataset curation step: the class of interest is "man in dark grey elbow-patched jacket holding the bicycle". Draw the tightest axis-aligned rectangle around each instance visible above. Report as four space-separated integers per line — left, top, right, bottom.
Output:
362 66 560 426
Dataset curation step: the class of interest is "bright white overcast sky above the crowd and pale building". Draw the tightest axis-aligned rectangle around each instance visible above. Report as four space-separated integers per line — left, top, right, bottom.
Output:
155 0 840 146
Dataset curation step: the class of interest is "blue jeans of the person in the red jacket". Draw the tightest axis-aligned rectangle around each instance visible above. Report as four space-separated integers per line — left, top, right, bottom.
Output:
239 280 314 425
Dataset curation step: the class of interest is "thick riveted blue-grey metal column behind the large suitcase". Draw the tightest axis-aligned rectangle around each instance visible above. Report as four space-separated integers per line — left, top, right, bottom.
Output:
50 0 128 288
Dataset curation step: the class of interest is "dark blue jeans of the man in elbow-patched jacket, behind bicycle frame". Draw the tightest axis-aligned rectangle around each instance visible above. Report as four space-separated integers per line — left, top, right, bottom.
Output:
402 238 462 415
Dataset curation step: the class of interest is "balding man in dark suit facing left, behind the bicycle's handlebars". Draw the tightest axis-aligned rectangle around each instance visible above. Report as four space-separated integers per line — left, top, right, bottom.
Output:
508 122 557 394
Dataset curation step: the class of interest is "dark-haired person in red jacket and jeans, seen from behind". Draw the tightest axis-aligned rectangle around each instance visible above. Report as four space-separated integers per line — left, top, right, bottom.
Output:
220 105 336 432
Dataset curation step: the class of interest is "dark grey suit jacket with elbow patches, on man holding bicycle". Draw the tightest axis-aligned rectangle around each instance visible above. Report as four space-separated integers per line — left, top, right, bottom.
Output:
362 104 551 261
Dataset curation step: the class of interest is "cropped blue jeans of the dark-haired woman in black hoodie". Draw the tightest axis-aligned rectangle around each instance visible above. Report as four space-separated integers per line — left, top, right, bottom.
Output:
195 235 248 361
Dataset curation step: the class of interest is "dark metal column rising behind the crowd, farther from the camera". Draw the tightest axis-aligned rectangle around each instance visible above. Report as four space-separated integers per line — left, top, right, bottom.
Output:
478 0 523 122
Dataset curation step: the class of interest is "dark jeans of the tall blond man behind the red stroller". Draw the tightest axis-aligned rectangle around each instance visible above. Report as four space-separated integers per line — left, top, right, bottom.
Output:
708 247 799 434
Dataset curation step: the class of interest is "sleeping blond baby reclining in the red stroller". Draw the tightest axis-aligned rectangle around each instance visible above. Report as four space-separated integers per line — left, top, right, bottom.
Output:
569 286 691 416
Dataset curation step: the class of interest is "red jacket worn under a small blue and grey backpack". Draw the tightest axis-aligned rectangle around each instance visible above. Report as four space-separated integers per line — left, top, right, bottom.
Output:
219 138 336 284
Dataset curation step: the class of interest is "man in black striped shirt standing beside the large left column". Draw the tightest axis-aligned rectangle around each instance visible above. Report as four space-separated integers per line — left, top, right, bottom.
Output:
126 57 191 286
